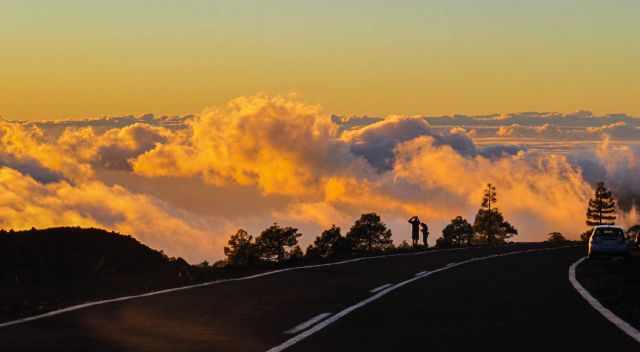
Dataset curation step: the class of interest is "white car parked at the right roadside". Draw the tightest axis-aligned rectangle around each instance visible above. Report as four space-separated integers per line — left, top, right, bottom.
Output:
589 225 631 260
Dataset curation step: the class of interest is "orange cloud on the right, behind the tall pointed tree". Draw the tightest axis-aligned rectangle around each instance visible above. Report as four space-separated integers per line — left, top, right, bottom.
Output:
394 137 591 239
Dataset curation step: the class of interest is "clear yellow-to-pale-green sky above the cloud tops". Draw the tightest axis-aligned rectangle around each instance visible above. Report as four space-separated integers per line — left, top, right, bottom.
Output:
0 0 640 120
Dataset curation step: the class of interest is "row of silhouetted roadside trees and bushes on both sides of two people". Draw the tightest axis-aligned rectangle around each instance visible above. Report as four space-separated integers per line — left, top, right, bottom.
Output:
218 184 518 267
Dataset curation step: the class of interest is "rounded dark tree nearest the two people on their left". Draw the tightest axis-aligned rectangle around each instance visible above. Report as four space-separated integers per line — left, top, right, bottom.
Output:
347 213 393 252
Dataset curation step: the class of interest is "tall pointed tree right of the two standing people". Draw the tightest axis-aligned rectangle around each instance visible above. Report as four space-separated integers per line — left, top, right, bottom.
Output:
473 183 518 245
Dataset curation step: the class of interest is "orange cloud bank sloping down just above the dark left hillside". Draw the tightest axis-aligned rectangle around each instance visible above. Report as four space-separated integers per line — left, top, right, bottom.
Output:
0 168 224 261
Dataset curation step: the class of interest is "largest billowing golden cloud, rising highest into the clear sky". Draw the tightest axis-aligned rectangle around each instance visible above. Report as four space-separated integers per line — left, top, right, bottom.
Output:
133 95 366 195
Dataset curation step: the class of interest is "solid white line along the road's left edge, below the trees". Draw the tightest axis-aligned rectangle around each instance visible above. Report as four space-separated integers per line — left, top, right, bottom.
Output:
0 242 473 328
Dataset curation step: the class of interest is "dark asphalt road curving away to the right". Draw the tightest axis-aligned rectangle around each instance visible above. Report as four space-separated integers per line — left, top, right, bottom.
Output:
0 245 639 351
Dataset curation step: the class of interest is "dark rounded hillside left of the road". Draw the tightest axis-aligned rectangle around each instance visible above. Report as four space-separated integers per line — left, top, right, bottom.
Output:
0 227 195 320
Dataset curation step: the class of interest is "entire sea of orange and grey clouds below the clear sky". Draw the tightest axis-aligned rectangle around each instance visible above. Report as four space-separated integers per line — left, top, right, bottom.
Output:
0 95 640 262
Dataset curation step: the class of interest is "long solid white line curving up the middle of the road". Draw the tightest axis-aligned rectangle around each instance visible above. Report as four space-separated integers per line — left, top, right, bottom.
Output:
267 246 578 352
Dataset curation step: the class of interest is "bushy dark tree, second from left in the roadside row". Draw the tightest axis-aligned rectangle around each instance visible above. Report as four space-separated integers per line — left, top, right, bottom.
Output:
256 224 302 262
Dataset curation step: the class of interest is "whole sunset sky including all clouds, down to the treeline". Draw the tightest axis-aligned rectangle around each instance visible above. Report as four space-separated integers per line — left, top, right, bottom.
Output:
0 0 640 263
